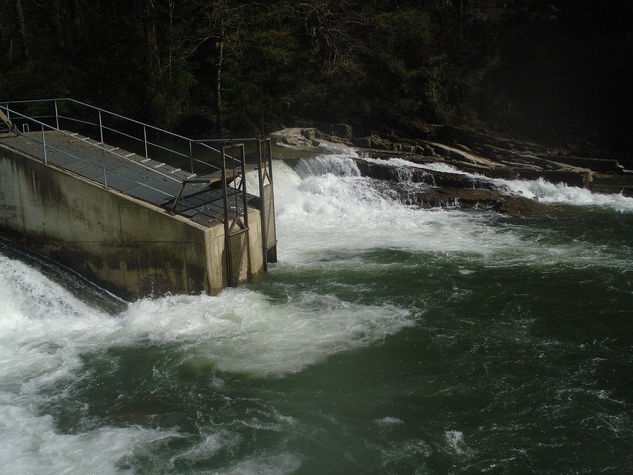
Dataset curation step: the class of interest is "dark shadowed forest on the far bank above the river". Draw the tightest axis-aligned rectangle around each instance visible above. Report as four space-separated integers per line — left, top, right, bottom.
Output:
0 0 633 154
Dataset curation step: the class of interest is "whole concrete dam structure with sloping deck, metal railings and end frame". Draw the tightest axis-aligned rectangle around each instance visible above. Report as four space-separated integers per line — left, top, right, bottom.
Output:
0 98 277 300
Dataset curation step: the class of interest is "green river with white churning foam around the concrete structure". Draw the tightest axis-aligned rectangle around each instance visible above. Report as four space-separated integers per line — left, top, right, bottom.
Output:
0 149 633 474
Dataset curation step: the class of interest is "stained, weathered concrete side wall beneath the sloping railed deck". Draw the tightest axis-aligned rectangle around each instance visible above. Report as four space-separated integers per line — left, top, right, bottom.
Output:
0 145 263 300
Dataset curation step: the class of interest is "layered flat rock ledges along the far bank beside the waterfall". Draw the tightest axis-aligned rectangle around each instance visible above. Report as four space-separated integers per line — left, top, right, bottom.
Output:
272 125 633 216
